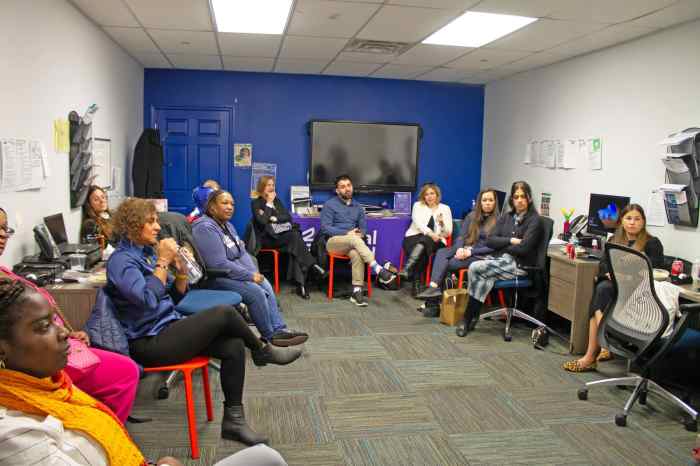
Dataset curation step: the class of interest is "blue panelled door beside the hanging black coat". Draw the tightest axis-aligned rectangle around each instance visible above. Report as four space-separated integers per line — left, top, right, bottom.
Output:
151 107 233 215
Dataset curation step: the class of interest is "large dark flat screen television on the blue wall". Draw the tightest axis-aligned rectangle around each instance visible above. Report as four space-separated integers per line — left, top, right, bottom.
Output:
309 120 421 192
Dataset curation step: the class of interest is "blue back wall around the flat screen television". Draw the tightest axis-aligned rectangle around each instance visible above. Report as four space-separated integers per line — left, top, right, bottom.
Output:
144 69 484 233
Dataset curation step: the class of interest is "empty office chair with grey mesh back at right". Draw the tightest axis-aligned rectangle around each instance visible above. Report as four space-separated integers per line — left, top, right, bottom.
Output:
578 243 700 432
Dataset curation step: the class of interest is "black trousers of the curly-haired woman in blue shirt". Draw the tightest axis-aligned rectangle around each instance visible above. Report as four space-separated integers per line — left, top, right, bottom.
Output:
129 306 262 405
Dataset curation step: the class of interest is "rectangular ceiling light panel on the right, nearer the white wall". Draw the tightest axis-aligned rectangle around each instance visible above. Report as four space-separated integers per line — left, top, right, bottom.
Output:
423 11 537 47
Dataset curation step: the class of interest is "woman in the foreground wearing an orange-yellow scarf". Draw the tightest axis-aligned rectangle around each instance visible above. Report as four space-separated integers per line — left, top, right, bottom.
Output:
0 277 286 466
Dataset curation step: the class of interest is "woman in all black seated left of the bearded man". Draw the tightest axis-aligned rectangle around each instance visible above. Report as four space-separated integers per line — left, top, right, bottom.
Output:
250 176 326 299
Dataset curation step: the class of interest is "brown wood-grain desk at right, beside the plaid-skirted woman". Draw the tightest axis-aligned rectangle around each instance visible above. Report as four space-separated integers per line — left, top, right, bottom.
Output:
547 246 598 354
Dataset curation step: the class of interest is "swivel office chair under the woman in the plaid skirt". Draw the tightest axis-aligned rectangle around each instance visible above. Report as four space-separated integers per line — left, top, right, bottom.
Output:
480 217 563 341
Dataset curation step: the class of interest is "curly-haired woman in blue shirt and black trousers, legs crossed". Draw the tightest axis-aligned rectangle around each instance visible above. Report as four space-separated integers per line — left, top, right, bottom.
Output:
106 198 301 445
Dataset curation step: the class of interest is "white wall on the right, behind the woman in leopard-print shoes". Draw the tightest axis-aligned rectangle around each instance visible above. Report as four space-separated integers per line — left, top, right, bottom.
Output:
481 21 700 260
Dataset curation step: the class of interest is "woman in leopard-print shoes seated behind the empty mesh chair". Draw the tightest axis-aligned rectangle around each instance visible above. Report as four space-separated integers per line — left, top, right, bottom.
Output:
562 204 664 372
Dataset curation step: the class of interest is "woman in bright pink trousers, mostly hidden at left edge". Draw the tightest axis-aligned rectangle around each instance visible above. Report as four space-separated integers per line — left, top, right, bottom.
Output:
0 207 139 423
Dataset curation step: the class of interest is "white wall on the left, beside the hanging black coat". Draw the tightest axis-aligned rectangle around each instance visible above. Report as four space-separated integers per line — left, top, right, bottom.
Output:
0 0 143 265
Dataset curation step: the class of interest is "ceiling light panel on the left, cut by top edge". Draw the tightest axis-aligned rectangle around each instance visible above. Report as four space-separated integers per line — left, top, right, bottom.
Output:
211 0 292 34
